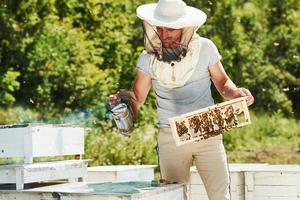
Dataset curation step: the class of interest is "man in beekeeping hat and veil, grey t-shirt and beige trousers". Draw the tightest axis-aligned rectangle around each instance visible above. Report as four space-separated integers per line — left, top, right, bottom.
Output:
110 0 254 200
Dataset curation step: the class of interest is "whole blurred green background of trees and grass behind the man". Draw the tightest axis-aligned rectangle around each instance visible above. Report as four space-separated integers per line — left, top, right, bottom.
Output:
0 0 300 165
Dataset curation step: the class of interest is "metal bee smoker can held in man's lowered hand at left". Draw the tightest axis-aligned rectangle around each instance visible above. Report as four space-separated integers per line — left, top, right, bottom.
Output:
109 93 133 136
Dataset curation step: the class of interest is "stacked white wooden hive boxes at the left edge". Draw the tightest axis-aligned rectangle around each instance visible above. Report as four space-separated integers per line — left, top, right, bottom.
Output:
0 124 87 189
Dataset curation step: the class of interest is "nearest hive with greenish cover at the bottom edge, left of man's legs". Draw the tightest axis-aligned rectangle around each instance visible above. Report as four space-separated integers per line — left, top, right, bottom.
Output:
0 182 183 200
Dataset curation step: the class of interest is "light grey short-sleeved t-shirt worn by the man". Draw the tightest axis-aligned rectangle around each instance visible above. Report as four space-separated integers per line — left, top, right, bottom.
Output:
137 37 221 128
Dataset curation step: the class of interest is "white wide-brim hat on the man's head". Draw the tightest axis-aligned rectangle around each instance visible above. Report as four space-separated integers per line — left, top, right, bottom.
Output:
136 0 206 29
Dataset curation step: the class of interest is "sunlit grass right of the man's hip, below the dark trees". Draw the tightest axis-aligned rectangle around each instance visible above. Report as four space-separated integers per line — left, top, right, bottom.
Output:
224 113 300 164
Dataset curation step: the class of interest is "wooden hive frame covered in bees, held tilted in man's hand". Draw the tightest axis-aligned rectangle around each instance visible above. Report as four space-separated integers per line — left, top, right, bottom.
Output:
169 97 251 146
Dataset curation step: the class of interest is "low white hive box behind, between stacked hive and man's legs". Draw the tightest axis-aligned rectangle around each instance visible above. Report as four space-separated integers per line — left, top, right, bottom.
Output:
86 165 155 181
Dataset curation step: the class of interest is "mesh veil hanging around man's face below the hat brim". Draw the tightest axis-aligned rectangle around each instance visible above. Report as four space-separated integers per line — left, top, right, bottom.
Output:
143 21 197 63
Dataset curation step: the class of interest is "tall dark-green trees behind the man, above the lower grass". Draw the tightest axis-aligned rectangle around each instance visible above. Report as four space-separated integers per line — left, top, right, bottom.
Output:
0 0 300 115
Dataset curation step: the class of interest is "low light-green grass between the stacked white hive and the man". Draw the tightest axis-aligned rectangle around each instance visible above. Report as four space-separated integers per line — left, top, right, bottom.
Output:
84 123 157 166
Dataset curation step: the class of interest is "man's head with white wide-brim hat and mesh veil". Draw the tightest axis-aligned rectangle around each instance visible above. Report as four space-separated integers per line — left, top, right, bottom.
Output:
137 0 206 62
